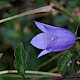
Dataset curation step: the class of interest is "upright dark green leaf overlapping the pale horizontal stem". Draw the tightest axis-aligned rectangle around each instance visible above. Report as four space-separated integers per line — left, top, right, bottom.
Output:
14 43 27 76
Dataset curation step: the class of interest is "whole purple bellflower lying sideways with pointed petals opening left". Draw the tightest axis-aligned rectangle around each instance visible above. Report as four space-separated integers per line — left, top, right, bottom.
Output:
30 21 76 58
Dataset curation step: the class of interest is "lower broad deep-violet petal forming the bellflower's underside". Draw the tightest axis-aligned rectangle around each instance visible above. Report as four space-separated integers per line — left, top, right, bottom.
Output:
46 38 75 52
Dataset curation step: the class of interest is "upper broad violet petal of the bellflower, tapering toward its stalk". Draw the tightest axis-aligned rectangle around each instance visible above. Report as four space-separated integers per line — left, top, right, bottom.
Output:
45 26 76 40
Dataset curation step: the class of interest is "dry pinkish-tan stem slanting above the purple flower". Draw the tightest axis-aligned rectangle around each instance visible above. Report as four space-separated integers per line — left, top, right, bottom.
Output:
0 5 52 23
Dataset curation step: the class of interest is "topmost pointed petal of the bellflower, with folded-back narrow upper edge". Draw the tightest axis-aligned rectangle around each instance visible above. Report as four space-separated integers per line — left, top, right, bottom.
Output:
35 21 57 33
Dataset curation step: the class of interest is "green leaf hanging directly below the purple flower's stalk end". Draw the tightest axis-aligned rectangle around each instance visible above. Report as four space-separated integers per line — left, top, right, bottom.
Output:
58 51 72 74
